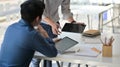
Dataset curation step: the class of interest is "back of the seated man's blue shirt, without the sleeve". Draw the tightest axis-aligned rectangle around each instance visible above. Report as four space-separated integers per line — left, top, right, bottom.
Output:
0 19 37 67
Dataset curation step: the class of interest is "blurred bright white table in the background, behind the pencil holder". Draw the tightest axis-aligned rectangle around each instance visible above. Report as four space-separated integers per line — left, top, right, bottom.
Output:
71 5 113 30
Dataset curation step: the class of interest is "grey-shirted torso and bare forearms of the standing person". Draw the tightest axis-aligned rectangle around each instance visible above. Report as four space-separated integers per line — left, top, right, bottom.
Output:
42 0 75 35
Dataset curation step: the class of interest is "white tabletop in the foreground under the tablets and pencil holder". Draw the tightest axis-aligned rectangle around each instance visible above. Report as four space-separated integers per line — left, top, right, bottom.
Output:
35 32 120 67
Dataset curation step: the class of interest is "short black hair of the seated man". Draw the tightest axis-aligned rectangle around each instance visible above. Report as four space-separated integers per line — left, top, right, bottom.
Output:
20 0 45 23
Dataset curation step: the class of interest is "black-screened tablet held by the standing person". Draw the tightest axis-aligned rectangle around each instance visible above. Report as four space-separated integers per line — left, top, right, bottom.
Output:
62 23 86 33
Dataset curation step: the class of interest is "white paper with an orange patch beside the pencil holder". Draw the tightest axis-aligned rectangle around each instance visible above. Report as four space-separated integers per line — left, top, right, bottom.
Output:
75 47 101 57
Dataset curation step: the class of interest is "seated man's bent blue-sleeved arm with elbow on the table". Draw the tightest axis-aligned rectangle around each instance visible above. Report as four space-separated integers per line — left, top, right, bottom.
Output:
32 29 57 57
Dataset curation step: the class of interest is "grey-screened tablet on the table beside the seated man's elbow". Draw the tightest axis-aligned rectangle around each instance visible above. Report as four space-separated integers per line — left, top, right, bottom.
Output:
55 37 78 54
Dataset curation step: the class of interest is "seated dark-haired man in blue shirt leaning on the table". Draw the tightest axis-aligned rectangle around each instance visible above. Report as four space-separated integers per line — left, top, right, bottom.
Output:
0 0 57 67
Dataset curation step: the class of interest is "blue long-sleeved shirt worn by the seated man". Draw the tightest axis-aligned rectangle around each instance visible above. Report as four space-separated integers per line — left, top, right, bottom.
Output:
0 19 57 67
